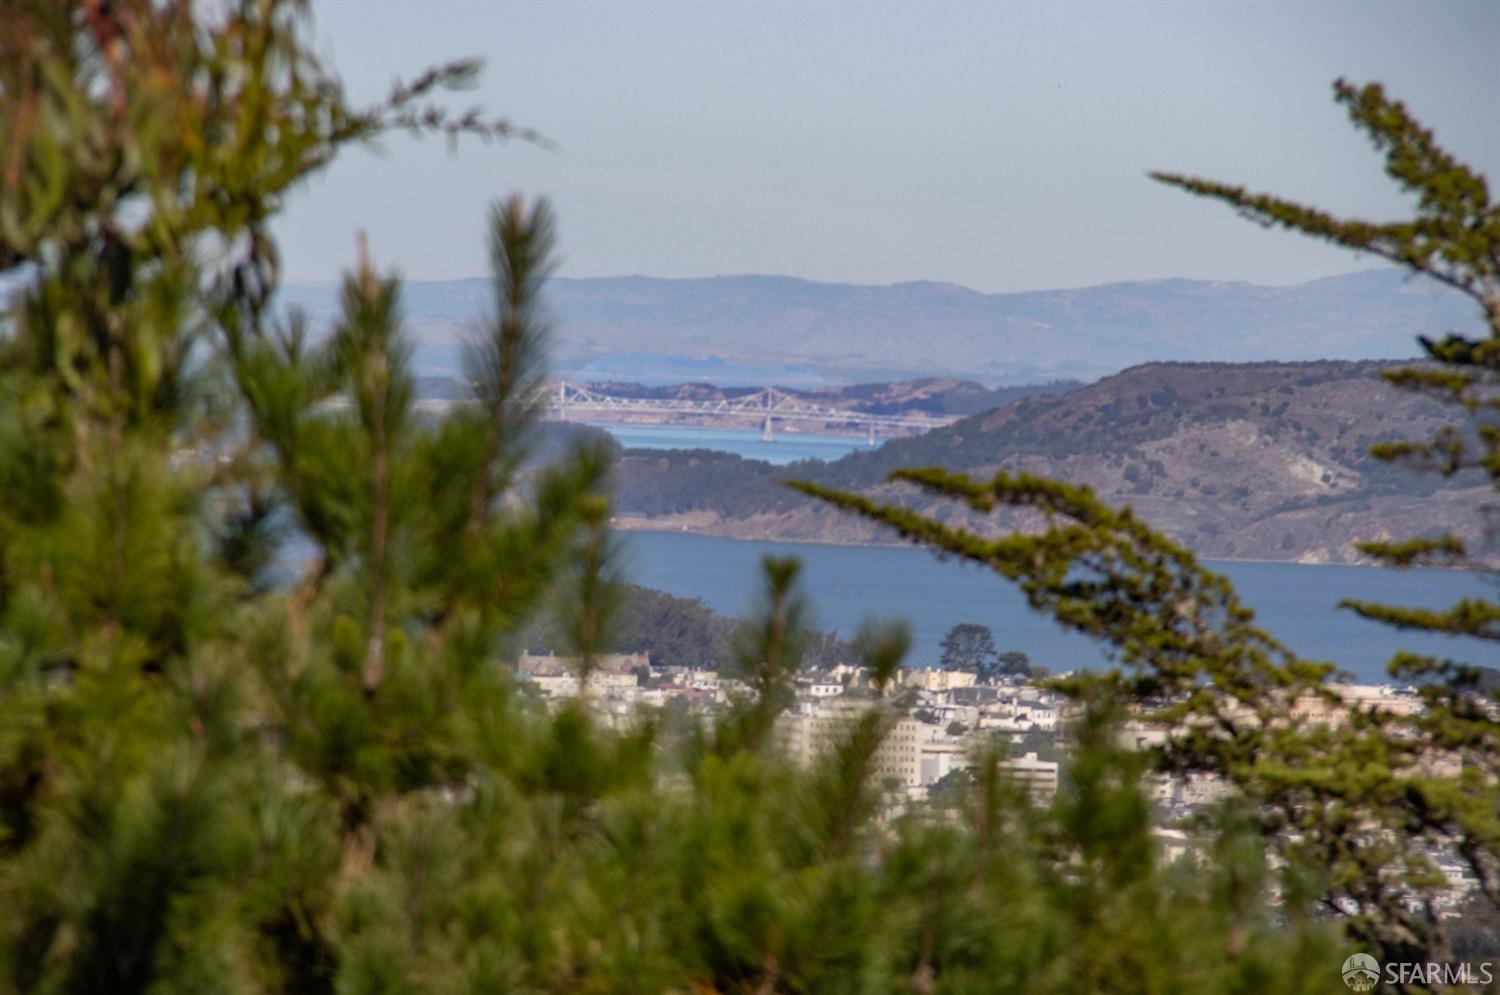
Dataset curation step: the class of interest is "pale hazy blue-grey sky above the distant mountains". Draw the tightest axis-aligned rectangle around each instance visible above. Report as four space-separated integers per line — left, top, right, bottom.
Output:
281 0 1500 291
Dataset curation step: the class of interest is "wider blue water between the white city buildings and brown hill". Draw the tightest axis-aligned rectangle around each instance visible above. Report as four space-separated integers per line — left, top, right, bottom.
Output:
623 533 1500 681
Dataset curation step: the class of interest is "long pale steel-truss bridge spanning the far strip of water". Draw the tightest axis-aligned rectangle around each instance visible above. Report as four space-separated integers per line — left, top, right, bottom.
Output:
548 381 959 441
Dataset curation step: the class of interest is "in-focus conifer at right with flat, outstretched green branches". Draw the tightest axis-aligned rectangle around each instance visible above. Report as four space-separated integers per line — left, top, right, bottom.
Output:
792 81 1500 960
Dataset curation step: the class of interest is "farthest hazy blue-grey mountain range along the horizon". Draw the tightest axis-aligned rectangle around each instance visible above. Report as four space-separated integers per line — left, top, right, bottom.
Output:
282 269 1478 387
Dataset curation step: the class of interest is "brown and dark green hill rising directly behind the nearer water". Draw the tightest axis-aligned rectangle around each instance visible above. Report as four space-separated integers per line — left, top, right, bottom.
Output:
618 362 1487 563
